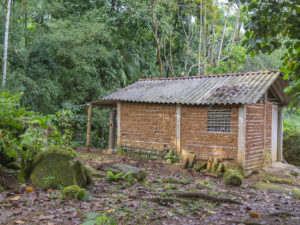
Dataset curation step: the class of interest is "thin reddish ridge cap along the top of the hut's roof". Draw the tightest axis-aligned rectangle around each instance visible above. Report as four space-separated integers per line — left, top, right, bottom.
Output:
139 70 280 81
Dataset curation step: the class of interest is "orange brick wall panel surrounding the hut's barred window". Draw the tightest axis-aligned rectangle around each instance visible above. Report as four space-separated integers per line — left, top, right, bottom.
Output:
181 106 238 160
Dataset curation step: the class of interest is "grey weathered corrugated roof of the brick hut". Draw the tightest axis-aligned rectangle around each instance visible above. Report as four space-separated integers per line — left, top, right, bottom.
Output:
100 71 288 105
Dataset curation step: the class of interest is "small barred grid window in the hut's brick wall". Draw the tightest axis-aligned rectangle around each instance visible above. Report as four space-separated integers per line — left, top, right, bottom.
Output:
207 109 231 133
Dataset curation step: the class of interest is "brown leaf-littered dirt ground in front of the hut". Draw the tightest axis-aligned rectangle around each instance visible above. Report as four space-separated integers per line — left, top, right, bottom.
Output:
0 151 300 225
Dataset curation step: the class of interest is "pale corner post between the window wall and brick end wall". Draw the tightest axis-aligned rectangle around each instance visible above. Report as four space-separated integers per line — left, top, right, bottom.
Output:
237 105 246 169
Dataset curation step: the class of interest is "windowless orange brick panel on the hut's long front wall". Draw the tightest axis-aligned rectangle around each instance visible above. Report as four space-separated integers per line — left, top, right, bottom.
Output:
120 102 176 151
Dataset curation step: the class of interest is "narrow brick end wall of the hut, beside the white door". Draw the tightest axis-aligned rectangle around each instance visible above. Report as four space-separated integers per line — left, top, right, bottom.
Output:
245 102 272 171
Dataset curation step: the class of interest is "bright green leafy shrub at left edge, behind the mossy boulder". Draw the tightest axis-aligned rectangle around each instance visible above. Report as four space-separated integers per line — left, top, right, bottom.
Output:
0 92 73 178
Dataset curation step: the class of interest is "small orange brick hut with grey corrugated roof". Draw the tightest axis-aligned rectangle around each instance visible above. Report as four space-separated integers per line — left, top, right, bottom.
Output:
88 71 289 172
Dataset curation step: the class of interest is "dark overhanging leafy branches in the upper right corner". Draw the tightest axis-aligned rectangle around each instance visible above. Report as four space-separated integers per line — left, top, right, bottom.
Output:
244 0 300 105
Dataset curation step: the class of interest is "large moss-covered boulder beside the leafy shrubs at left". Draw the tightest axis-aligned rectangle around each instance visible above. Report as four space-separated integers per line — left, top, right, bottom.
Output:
29 149 92 188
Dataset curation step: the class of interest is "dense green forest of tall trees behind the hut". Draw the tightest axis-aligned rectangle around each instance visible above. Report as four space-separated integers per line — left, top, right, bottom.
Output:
0 0 300 147
